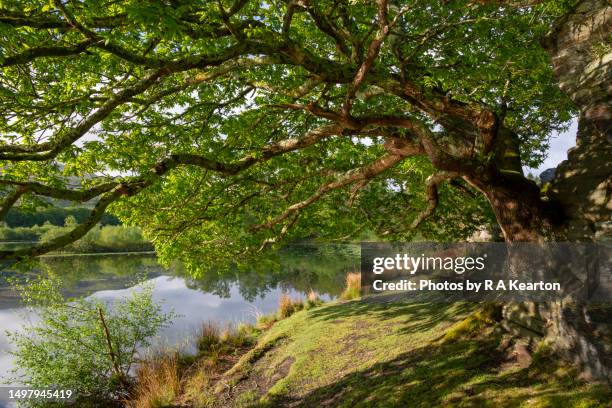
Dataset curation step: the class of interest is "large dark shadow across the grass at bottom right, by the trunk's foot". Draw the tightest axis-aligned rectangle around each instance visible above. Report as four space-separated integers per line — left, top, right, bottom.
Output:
271 338 612 408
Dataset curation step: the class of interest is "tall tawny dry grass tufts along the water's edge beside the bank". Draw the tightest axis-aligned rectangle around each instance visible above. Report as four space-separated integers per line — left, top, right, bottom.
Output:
127 291 323 408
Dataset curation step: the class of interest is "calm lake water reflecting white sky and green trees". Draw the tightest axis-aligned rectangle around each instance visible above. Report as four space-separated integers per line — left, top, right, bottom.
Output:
0 246 359 407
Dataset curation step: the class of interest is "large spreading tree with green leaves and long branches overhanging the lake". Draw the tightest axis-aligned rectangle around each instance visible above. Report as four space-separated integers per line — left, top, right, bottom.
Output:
0 0 612 380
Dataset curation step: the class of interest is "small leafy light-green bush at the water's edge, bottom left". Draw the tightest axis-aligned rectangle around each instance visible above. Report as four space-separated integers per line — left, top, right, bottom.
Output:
7 276 175 406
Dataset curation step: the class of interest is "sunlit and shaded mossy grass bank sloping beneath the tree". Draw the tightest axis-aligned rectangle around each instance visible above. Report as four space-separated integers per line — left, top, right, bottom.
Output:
131 294 612 408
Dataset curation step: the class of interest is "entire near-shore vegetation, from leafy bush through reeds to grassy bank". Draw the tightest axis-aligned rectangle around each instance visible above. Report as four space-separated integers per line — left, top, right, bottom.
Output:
5 274 612 408
